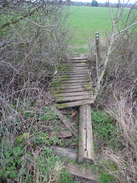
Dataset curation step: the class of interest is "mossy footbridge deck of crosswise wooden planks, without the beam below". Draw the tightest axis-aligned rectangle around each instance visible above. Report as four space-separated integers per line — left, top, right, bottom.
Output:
51 57 93 108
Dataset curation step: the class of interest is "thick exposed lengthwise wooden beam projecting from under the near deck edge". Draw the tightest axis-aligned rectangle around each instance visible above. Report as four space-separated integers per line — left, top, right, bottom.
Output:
78 105 94 162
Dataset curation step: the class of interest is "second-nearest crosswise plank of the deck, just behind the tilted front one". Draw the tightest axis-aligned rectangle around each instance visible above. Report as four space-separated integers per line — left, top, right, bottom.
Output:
55 94 93 102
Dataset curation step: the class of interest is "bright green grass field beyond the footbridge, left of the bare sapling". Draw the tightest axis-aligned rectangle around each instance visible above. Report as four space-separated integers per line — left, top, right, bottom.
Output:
68 6 128 54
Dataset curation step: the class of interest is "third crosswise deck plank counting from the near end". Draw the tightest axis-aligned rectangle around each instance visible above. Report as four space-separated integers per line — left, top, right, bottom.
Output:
55 91 92 97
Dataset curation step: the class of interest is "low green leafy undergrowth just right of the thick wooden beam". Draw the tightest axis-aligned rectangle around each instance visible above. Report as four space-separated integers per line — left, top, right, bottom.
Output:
91 110 119 151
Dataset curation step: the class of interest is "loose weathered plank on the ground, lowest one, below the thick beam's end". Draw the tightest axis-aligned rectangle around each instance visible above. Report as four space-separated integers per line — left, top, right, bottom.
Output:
65 163 97 183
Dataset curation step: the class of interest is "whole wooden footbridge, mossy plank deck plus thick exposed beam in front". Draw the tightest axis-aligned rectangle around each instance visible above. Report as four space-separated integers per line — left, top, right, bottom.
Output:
51 57 94 162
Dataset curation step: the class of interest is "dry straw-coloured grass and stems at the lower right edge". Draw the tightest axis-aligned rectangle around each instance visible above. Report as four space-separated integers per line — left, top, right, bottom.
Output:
104 98 137 182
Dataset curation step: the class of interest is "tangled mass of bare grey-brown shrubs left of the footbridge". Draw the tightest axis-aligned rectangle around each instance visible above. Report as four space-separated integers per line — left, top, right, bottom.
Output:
0 0 69 182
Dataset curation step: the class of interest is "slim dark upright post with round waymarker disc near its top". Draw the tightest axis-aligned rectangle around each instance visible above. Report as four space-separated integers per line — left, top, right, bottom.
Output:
95 32 100 78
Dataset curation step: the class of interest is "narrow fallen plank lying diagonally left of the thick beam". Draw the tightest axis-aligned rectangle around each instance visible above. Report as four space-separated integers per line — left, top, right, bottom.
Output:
54 108 78 135
